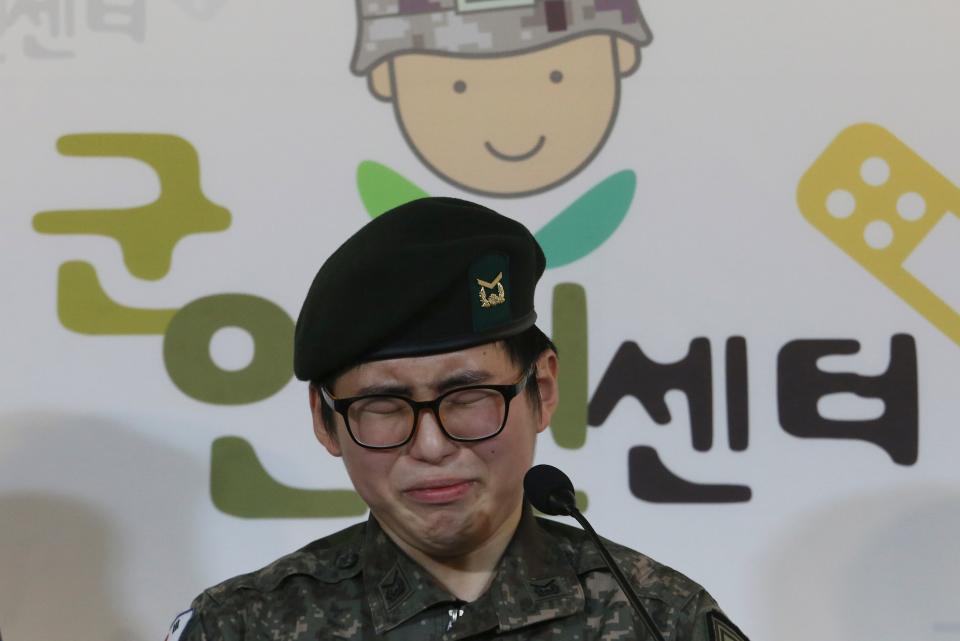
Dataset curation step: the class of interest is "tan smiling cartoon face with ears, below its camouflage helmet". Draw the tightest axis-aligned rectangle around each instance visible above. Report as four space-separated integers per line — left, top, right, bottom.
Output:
371 34 636 196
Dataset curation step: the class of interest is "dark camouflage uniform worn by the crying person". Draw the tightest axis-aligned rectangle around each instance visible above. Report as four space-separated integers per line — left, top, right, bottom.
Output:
181 511 745 641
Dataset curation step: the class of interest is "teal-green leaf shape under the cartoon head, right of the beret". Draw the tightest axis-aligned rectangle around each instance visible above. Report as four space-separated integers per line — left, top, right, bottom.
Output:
536 169 637 269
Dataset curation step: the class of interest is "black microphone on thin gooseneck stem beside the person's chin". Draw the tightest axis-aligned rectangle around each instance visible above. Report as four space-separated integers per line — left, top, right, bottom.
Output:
523 465 665 641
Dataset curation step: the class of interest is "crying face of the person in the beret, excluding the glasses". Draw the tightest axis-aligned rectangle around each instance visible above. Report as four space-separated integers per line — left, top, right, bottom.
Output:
310 343 557 558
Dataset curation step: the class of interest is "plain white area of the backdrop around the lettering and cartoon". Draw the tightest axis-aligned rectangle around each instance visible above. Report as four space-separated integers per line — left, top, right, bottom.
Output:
0 0 960 641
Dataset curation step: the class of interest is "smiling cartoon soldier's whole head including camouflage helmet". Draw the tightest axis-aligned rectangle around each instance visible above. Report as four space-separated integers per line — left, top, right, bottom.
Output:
353 0 650 196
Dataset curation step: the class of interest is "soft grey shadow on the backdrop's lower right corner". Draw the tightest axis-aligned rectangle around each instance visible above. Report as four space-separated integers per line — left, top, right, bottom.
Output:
757 484 960 641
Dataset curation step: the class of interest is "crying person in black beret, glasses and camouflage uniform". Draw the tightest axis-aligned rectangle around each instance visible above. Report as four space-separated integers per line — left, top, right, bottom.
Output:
169 198 745 641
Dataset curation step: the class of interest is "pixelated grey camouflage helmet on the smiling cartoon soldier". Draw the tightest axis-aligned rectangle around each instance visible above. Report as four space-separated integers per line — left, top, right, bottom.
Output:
351 0 652 76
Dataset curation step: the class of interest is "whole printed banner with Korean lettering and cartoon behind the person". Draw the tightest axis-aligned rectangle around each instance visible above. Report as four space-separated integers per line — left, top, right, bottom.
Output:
0 0 960 641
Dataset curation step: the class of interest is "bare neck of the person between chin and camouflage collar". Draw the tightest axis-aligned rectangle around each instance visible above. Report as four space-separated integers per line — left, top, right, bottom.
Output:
378 502 523 602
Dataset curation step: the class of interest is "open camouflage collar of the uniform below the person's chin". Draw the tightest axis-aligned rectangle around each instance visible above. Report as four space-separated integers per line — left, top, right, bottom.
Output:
361 507 585 639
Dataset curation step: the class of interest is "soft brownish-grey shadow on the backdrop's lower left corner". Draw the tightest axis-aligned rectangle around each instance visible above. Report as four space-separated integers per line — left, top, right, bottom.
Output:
0 412 207 641
